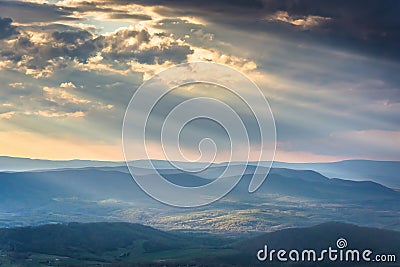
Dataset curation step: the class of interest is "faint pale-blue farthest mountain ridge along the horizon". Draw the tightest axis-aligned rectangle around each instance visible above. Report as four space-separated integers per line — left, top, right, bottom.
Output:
0 156 400 189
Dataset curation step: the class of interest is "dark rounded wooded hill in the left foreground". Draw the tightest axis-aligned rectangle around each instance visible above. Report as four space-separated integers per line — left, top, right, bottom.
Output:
0 223 196 258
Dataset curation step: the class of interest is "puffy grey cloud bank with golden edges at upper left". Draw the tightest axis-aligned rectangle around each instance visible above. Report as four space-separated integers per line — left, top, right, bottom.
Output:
0 22 193 77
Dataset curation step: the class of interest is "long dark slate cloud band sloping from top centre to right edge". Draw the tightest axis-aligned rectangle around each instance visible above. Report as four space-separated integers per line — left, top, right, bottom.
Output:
126 0 400 59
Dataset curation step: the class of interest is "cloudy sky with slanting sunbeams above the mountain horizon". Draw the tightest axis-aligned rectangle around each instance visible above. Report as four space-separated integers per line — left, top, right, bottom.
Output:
0 0 400 162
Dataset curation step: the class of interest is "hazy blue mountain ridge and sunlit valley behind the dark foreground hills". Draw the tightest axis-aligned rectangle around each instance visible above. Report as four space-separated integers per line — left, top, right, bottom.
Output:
0 165 400 235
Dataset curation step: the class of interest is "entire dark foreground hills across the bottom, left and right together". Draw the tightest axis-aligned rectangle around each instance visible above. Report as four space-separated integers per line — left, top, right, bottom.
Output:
0 223 400 266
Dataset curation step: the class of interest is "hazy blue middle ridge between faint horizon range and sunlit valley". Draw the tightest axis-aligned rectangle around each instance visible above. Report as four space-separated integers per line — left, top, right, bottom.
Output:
0 166 400 207
